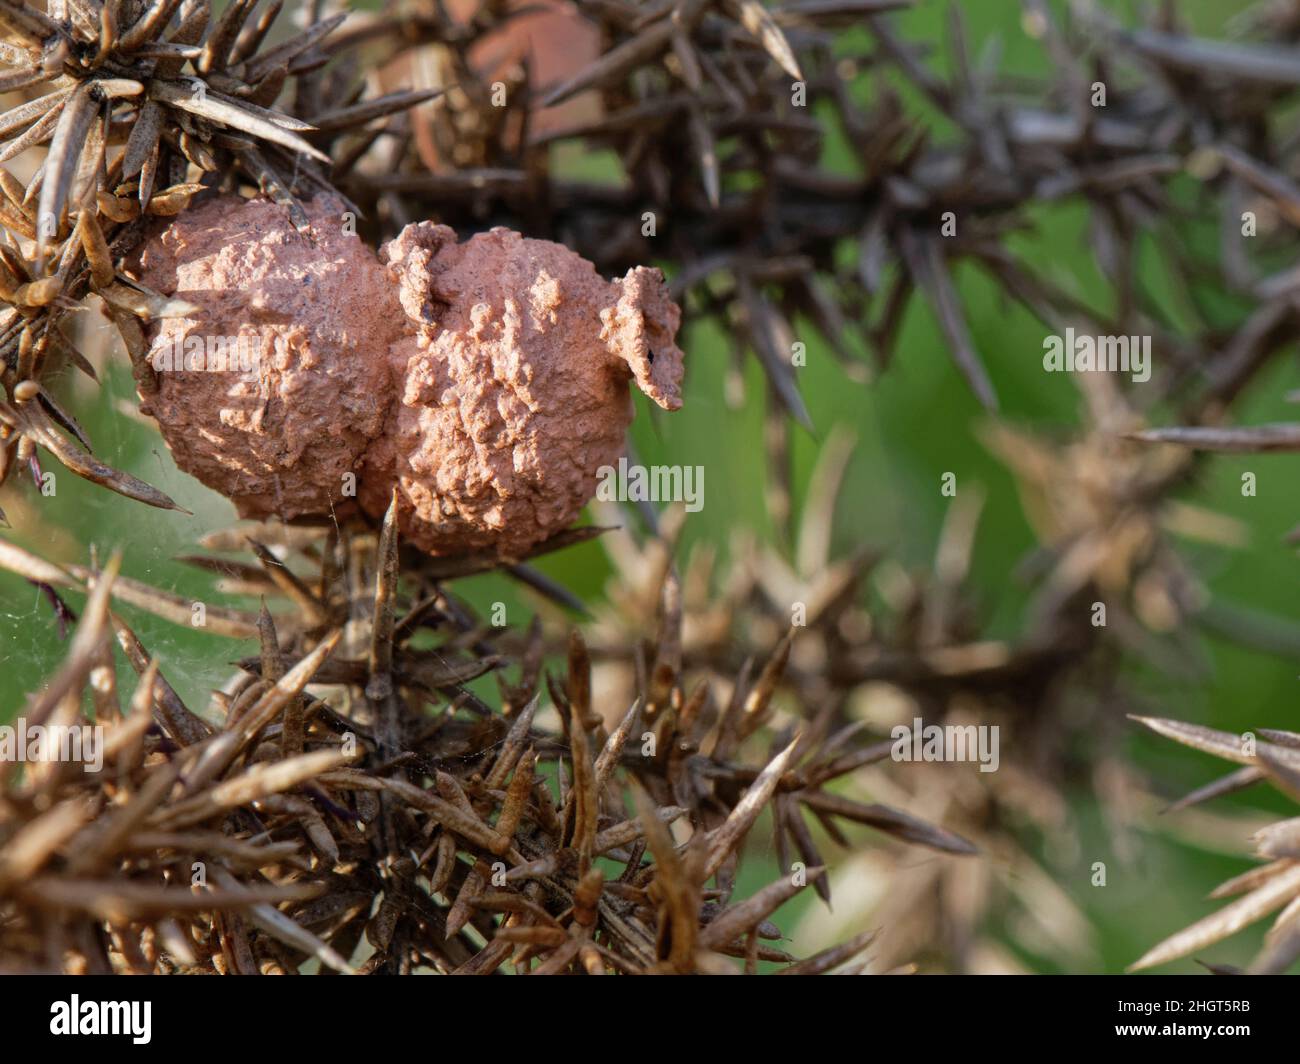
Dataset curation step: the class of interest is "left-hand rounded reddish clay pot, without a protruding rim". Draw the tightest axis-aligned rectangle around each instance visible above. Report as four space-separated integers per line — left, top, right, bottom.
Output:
135 196 402 519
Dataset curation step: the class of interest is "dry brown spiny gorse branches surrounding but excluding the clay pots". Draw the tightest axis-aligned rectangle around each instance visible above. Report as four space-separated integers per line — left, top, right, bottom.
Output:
0 0 1300 970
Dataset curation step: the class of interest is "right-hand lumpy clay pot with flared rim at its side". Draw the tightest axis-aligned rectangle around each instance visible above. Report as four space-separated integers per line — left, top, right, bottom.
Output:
361 222 683 555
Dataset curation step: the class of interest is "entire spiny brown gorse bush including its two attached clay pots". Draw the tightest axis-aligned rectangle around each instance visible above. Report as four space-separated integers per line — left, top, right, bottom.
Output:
0 0 1300 974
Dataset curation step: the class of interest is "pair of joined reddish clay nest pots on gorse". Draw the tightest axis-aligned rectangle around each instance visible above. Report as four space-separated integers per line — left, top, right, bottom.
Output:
129 198 683 557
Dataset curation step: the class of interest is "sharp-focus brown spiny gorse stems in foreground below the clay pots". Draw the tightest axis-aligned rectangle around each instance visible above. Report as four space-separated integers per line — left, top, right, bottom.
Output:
0 489 974 974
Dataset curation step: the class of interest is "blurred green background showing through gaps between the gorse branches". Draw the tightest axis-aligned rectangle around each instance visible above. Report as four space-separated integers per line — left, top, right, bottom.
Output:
0 0 1300 972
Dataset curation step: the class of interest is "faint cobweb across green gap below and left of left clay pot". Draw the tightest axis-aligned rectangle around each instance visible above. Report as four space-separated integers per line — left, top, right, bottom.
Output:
0 308 246 719
